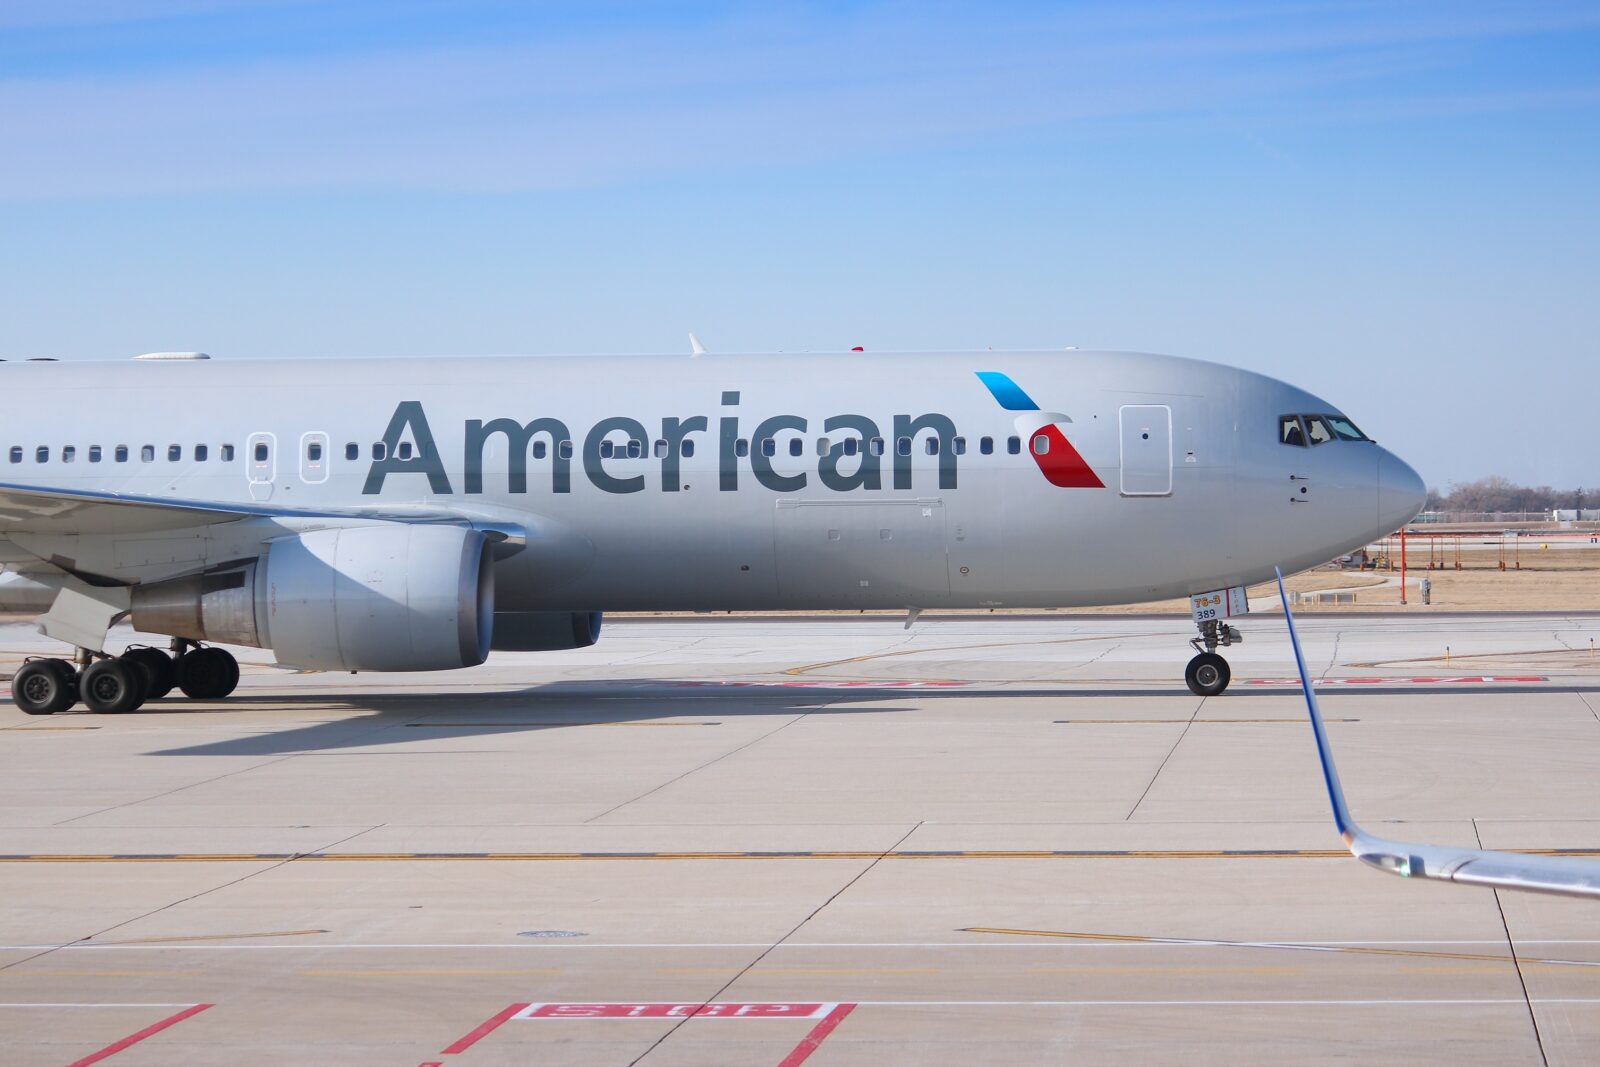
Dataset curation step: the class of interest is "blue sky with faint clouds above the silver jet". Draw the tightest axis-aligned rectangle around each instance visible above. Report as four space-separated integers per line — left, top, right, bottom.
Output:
0 0 1600 488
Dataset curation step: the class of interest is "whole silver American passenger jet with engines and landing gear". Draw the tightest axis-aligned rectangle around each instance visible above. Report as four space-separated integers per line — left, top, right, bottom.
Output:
0 350 1424 713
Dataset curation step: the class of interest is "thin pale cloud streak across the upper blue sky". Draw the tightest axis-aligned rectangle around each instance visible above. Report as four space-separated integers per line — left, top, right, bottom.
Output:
0 0 1600 198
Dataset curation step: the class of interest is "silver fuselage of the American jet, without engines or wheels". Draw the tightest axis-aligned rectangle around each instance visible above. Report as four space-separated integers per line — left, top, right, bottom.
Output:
0 352 1422 613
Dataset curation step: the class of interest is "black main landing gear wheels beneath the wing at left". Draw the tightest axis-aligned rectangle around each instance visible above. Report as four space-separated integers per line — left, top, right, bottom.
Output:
11 637 238 715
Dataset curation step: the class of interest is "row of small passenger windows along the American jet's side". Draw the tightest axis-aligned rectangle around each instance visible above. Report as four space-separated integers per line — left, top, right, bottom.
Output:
10 435 1036 462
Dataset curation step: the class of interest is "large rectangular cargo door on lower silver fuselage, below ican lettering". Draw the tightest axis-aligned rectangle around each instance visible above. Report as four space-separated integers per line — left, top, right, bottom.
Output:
773 498 950 606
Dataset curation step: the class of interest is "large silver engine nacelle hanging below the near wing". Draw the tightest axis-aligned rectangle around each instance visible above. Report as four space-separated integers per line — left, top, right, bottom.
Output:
133 525 494 670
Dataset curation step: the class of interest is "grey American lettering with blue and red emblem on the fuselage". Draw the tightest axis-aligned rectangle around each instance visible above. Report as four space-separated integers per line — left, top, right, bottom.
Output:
362 371 1102 496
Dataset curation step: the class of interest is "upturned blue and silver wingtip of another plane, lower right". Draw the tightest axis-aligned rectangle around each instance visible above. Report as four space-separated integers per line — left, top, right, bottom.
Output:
1278 571 1600 897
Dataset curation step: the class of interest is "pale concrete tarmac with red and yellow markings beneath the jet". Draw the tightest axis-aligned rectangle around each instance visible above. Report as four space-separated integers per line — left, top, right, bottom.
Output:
0 614 1600 1067
